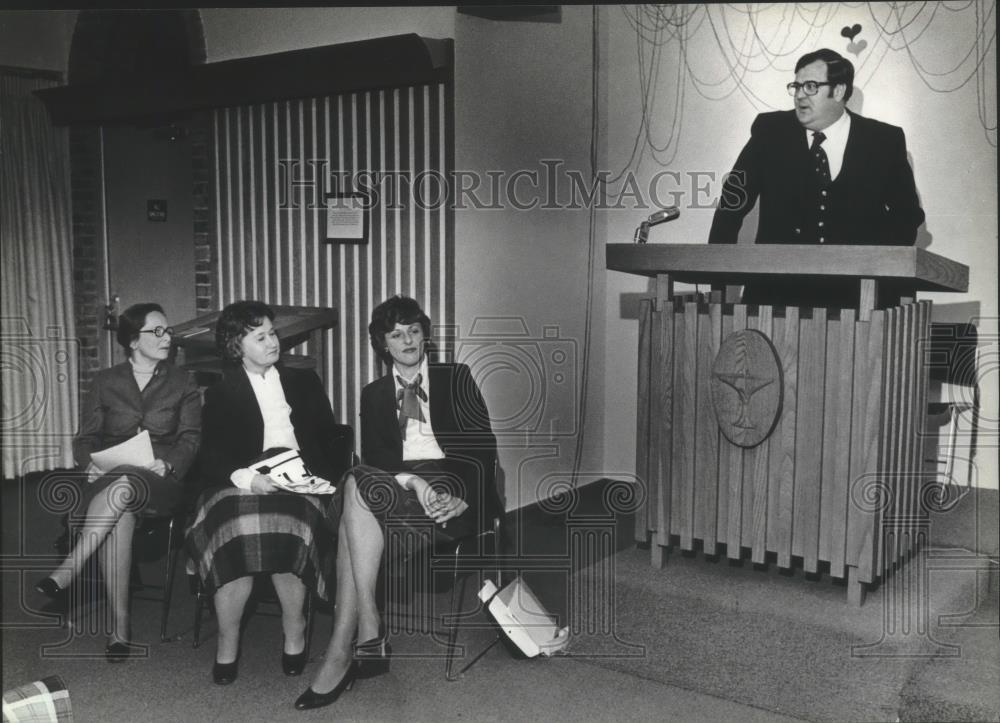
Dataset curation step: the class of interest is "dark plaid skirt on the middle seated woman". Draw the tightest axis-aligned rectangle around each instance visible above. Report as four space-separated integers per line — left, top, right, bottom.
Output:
185 487 337 600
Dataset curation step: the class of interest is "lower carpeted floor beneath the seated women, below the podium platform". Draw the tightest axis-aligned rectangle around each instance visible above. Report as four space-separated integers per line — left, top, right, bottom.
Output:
3 572 793 723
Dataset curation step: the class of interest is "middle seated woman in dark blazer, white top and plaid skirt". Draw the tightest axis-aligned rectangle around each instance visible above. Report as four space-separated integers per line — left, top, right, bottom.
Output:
187 301 347 685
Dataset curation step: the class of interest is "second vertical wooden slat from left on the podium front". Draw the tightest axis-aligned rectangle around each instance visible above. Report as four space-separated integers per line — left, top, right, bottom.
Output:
653 303 677 547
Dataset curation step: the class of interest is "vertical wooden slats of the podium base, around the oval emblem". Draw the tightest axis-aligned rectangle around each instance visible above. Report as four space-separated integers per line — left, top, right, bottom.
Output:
636 299 930 582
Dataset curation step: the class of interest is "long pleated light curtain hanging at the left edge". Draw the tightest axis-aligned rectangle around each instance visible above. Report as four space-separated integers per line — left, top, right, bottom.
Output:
0 71 79 479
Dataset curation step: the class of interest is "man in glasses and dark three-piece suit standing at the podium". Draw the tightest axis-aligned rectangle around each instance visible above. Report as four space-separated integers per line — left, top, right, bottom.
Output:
708 48 924 307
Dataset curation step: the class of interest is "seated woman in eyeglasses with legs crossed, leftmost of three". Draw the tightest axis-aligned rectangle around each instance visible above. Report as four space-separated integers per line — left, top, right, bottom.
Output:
36 303 201 663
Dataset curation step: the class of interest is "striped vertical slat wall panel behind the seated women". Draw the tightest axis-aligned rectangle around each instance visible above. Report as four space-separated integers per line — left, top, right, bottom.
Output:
210 83 455 426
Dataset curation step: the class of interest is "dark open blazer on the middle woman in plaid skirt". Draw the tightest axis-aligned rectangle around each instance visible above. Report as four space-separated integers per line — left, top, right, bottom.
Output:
199 364 345 487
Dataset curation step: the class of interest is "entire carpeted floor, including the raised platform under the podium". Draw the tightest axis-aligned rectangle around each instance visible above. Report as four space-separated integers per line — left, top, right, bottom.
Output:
0 476 1000 722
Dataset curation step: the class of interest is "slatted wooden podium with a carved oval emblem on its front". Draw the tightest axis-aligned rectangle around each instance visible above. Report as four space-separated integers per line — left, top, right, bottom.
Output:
607 244 968 605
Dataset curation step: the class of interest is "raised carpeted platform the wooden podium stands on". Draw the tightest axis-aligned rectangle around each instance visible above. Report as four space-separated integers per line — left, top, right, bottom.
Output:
571 550 1000 720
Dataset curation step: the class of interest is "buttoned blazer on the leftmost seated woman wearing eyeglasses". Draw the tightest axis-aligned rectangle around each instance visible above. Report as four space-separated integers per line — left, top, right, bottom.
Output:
73 361 201 479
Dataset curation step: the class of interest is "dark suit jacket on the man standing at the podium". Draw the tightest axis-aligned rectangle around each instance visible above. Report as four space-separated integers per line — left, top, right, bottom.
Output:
708 111 924 306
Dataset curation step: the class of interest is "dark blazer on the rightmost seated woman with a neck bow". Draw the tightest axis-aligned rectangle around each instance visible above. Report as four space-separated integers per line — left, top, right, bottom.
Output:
361 364 503 519
